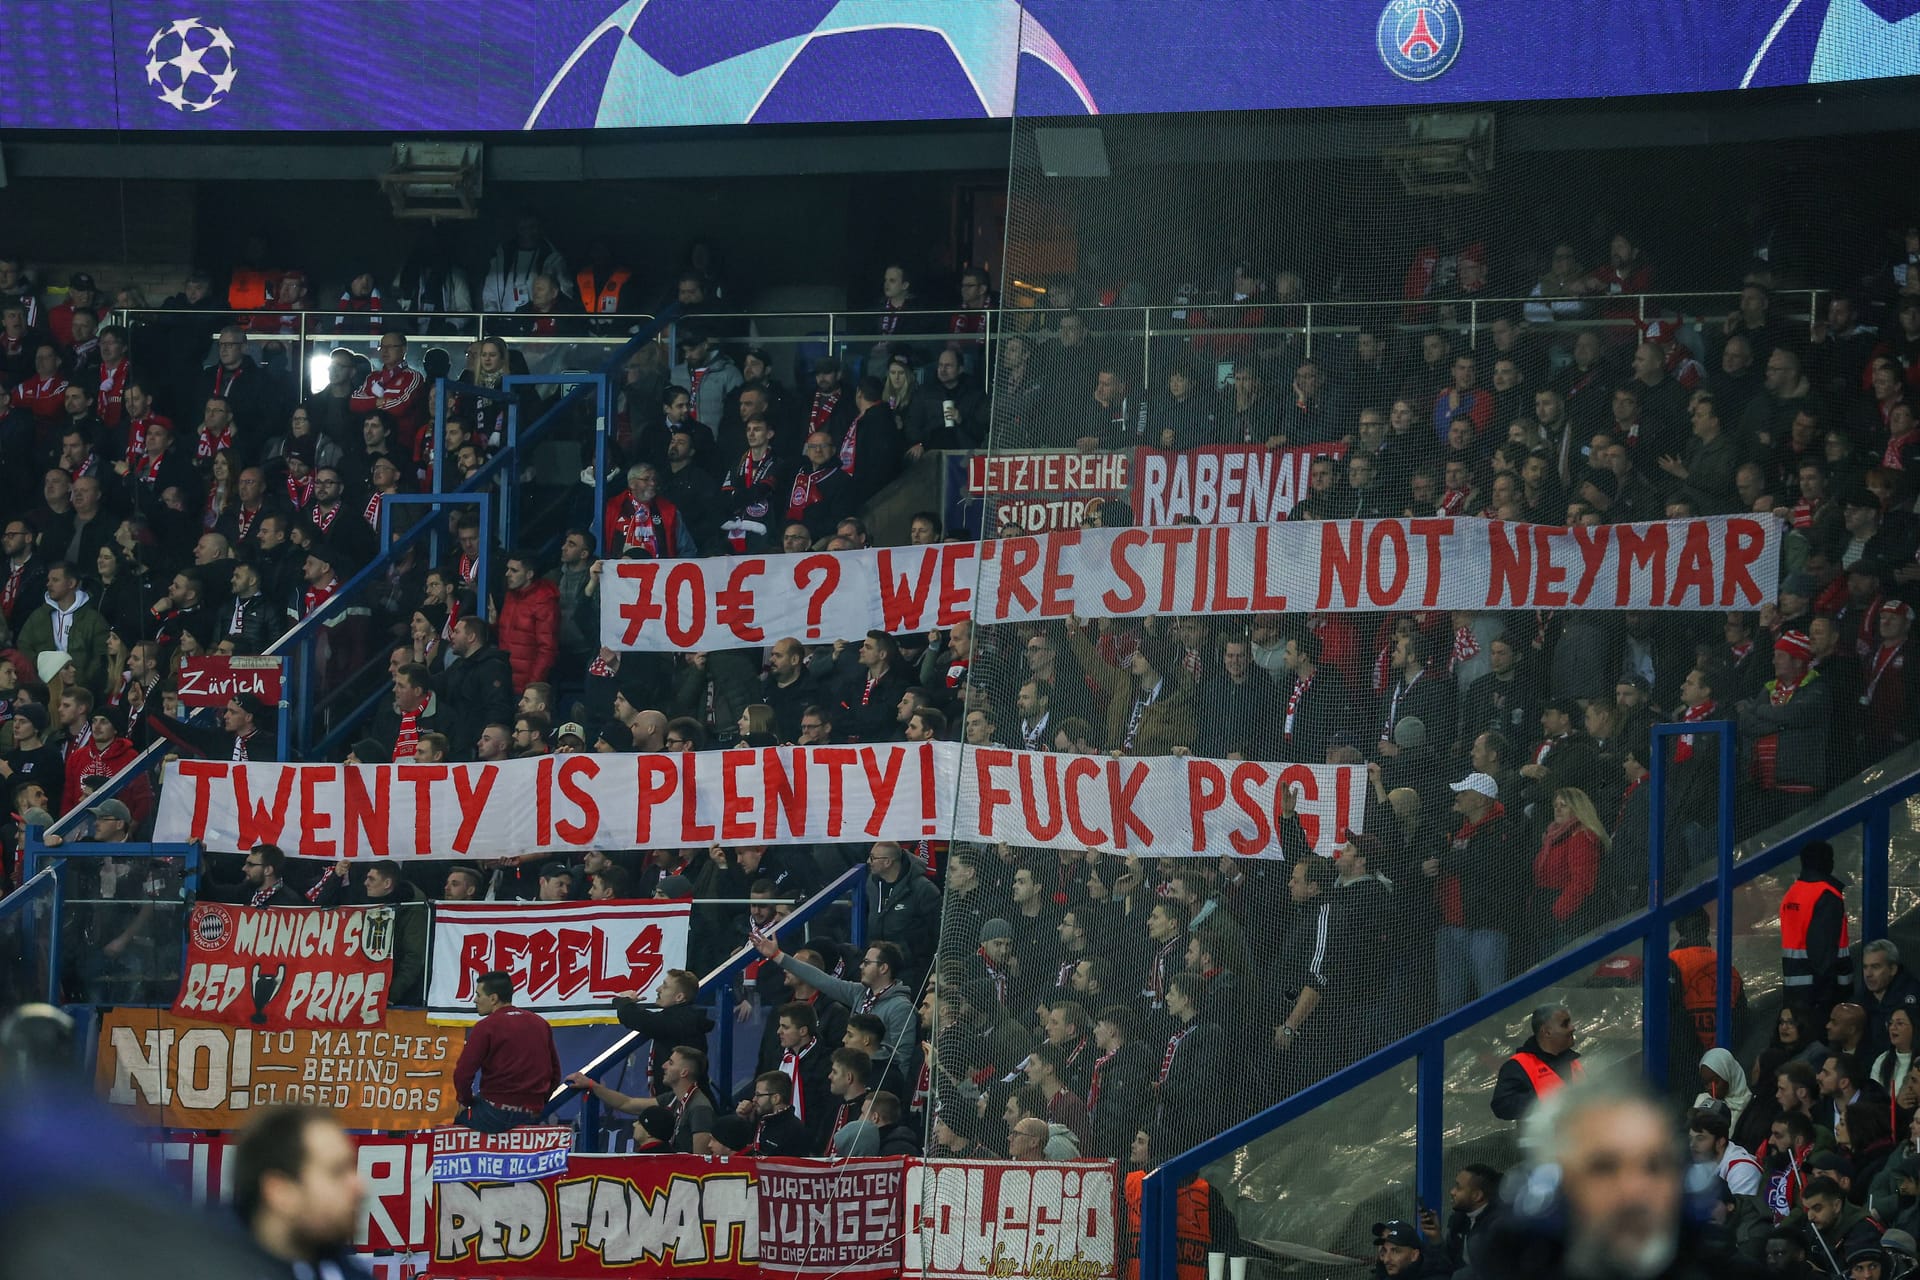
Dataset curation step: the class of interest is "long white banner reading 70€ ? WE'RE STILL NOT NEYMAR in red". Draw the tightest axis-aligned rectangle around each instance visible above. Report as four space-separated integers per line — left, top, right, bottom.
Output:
601 516 1782 652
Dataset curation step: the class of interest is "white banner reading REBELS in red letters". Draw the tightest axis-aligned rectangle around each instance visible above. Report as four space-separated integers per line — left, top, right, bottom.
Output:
428 901 691 1027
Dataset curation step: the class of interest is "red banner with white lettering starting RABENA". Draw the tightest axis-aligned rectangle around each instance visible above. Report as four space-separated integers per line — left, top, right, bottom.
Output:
1129 445 1346 526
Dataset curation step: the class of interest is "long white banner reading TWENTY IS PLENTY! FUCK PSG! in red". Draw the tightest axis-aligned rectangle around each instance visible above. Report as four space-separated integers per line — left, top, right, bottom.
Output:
154 743 1367 860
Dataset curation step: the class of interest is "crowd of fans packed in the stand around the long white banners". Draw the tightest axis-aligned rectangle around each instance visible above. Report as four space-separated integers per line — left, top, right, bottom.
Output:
0 214 1920 1274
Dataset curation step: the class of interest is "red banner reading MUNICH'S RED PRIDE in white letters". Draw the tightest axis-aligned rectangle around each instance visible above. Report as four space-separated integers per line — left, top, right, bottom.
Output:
173 902 394 1031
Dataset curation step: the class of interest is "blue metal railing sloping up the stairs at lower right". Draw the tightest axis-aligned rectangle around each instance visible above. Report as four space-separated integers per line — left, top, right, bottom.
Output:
1139 720 1920 1280
